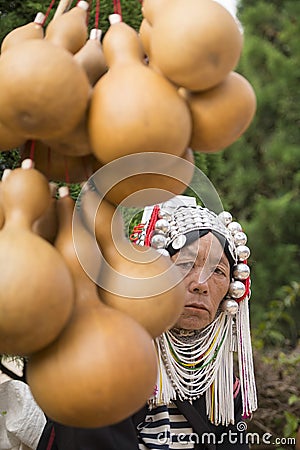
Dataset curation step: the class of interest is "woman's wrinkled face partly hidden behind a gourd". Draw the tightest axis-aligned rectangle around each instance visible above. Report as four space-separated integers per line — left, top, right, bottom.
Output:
172 233 230 330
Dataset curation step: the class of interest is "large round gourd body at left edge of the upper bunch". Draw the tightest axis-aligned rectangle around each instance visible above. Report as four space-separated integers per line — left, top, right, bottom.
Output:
0 39 91 139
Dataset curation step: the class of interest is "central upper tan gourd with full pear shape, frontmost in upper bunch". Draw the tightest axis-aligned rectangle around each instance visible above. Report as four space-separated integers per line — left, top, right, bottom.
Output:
88 14 191 164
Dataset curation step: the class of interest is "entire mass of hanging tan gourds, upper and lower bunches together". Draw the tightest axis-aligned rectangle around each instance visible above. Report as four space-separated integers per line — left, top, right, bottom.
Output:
0 0 255 427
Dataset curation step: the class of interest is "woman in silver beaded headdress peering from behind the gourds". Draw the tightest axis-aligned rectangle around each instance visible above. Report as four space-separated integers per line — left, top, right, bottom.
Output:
38 196 256 450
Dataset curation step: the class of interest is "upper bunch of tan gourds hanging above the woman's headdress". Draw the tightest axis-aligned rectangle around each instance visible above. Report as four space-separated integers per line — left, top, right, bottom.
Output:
0 0 256 195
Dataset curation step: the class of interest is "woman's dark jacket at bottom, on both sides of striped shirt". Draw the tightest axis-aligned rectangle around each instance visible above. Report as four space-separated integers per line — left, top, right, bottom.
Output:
37 393 249 450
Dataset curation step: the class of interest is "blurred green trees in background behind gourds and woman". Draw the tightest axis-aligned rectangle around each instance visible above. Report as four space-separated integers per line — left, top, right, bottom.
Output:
0 0 300 442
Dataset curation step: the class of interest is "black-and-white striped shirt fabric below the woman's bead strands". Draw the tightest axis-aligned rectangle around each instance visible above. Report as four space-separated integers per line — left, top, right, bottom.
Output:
137 403 197 450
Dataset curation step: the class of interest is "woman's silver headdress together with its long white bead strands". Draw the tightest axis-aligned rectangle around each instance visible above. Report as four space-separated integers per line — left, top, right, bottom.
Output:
131 196 257 425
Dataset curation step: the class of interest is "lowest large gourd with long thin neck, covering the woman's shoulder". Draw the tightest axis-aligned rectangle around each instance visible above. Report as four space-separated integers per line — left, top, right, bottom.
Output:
27 189 156 427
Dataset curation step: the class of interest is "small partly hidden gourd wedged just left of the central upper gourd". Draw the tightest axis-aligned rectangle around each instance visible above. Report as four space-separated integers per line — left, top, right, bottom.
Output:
74 28 107 86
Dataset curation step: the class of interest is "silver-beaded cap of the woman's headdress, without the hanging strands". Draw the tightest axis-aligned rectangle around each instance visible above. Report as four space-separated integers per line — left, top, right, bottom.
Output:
132 195 250 301
